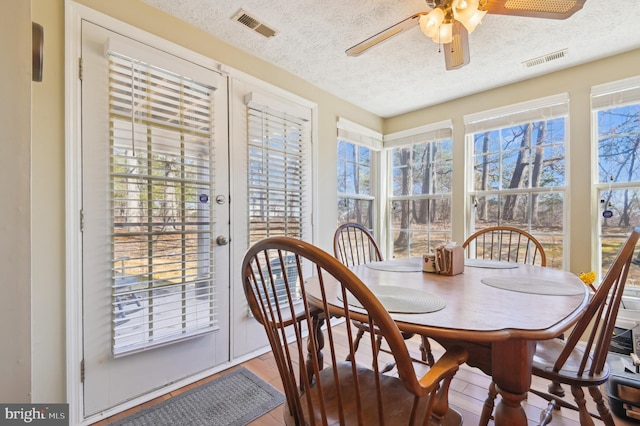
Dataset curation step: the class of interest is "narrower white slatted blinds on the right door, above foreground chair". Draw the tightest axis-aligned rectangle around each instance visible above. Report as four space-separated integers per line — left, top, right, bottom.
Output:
245 94 311 244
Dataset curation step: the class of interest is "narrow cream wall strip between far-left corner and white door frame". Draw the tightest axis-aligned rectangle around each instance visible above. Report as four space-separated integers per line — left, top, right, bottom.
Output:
32 0 67 402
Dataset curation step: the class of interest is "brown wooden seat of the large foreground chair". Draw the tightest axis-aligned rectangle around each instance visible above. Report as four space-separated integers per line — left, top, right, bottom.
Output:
284 362 462 426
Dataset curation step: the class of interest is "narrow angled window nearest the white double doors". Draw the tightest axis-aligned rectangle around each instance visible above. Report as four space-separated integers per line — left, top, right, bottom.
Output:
337 118 382 230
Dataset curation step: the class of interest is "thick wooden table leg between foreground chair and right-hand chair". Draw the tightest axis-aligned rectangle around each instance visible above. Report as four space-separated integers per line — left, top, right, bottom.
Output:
491 340 536 426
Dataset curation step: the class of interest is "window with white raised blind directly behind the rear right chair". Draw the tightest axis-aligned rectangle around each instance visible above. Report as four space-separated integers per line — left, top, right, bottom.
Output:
465 94 568 268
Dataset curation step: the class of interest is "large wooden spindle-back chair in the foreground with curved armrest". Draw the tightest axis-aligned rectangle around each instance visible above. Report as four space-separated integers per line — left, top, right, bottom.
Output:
242 237 466 426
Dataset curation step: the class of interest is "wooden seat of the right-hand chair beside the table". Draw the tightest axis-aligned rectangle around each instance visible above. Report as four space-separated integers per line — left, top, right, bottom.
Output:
533 339 610 387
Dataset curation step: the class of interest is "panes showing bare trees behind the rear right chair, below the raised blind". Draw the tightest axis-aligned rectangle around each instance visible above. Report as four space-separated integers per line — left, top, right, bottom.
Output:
472 117 566 268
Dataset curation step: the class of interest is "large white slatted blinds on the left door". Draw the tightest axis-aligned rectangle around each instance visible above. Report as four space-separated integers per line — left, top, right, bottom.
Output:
108 53 218 355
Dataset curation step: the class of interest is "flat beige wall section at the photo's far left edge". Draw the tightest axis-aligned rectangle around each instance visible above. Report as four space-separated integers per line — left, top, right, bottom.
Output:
0 0 31 403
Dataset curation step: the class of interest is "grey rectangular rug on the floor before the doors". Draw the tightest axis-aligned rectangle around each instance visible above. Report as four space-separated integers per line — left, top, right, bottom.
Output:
109 367 285 426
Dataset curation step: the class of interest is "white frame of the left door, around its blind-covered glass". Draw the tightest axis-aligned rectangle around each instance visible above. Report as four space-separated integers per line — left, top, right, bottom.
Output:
82 21 230 416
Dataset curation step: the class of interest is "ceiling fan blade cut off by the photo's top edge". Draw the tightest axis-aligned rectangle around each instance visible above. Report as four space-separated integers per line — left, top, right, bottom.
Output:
480 0 587 19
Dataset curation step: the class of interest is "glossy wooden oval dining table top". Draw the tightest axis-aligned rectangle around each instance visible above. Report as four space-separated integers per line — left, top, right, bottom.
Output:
309 258 589 342
